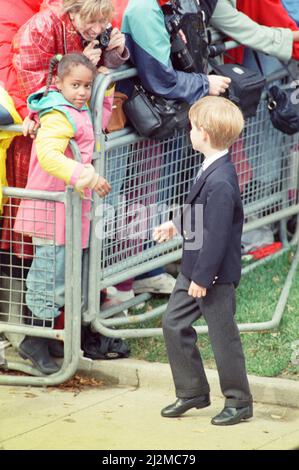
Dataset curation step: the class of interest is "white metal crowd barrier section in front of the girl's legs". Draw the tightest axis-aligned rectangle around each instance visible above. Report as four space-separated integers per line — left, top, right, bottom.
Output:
0 137 82 386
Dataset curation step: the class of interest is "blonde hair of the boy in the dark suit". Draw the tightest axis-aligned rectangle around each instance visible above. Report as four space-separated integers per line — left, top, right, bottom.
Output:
189 96 244 150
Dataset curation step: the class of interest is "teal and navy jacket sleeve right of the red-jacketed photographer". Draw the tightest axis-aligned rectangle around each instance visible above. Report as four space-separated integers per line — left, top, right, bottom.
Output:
121 0 209 104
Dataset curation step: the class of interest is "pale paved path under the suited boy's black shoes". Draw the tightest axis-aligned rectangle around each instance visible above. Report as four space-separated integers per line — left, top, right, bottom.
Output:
0 385 299 450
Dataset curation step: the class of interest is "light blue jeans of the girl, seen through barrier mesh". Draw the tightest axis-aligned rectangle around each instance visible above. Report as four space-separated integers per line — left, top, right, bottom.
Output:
26 245 65 319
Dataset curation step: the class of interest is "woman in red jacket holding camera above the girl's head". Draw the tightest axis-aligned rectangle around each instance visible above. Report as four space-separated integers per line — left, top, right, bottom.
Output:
13 0 129 106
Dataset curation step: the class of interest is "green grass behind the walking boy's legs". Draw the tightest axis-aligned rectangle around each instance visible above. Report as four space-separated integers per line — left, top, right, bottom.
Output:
128 250 299 380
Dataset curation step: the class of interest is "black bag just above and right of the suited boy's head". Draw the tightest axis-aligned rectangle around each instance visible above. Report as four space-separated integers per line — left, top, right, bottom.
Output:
211 61 266 118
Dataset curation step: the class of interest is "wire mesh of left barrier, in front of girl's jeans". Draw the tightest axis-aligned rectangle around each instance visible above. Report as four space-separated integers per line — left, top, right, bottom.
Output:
0 193 62 327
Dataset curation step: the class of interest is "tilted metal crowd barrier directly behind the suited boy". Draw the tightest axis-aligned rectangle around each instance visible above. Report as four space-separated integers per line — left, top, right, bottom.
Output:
88 64 299 338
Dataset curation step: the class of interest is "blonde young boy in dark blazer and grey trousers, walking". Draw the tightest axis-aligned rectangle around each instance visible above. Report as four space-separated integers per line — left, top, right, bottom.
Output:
154 96 252 426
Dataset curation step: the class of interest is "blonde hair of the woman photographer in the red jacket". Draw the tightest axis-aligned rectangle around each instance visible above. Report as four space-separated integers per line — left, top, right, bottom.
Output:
63 0 114 22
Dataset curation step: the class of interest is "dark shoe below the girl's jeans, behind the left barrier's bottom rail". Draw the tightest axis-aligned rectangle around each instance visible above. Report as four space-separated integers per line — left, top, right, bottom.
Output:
19 336 60 375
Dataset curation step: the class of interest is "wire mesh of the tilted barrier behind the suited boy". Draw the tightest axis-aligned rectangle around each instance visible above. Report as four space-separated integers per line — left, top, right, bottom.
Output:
93 85 299 279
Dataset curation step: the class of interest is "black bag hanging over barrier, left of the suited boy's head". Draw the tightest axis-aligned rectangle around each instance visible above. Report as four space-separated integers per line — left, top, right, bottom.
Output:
124 83 189 139
